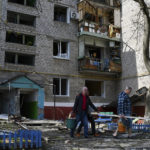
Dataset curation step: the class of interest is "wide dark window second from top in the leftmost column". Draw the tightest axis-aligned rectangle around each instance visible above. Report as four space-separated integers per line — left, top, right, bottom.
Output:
7 11 35 26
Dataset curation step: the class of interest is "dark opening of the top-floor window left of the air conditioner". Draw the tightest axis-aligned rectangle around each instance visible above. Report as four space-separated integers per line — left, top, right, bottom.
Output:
54 6 67 22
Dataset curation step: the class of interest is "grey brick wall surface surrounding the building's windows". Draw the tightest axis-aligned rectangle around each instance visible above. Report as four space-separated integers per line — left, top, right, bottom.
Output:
0 0 117 119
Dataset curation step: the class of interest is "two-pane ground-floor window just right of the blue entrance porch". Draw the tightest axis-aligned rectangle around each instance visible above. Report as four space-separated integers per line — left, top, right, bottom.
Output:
53 78 69 96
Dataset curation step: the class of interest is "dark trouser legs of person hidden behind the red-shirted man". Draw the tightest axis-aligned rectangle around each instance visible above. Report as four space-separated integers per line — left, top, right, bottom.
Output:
77 115 95 135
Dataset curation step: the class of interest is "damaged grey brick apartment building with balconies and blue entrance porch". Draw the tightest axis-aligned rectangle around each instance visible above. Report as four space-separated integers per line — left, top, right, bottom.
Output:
0 0 122 119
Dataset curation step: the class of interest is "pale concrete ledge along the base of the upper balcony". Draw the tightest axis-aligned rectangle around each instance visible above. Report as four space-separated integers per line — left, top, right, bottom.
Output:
78 31 121 42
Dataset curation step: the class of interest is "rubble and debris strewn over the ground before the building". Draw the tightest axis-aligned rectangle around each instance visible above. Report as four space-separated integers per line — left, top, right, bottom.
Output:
0 117 150 150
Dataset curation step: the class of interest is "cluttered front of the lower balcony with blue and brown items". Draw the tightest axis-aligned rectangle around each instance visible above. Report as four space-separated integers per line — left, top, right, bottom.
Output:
78 57 121 75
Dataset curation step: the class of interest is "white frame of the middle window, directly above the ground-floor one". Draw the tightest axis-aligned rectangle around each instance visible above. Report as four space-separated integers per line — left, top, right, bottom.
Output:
53 40 70 60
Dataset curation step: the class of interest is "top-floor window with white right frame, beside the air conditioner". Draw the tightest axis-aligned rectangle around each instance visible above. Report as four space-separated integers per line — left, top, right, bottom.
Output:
54 5 70 23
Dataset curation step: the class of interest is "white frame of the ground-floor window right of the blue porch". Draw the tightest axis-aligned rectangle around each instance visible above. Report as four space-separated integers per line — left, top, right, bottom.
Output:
53 77 70 97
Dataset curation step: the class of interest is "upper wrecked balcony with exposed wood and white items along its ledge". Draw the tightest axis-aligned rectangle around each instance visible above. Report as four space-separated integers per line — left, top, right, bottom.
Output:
78 0 121 42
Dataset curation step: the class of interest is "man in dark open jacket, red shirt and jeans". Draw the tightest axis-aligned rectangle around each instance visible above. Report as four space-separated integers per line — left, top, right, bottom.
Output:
71 87 97 138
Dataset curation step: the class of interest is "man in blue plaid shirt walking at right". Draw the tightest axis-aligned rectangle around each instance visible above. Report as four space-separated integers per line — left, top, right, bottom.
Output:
113 86 132 137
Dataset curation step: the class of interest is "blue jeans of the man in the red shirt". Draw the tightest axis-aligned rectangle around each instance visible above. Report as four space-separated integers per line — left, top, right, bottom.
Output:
70 111 88 137
